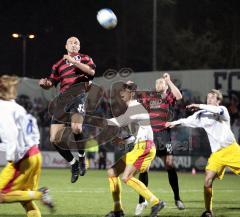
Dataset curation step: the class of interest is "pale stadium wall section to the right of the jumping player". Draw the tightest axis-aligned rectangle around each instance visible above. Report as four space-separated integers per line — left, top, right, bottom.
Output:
95 69 240 100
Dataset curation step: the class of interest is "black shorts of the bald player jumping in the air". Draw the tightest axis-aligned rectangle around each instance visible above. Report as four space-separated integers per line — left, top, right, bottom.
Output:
49 83 87 124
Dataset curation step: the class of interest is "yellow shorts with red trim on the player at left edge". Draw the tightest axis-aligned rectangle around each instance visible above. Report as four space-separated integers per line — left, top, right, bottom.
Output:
0 146 42 193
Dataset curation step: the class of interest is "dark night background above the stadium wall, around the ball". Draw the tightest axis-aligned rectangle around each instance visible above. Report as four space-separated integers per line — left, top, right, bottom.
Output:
0 0 240 78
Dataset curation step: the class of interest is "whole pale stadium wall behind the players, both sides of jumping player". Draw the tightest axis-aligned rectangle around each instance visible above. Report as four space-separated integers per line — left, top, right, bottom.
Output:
19 68 240 100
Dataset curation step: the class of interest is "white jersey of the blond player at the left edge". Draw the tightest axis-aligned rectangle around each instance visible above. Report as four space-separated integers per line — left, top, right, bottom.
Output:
0 100 40 163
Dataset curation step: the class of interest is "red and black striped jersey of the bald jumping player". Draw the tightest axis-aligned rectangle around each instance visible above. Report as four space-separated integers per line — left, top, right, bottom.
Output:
49 54 96 93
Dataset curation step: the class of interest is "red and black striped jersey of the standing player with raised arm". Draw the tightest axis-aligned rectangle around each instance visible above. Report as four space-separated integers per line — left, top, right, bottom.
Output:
139 91 176 132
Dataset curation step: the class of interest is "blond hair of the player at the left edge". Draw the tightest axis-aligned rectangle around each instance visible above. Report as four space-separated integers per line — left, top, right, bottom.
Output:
0 75 19 100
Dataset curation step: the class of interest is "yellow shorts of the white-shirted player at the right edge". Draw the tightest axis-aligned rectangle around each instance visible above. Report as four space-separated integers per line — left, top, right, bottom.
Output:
206 143 240 179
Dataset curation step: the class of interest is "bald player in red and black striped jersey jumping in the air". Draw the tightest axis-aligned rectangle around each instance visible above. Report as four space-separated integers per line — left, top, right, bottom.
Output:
39 37 96 183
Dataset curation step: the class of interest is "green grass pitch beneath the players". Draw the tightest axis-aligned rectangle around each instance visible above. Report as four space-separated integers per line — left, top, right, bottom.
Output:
0 169 240 217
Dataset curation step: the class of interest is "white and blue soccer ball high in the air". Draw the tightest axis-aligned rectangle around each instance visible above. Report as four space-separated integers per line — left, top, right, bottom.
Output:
97 8 117 29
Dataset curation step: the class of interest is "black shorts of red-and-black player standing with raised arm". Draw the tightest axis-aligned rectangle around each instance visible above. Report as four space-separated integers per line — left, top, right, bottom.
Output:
153 129 173 157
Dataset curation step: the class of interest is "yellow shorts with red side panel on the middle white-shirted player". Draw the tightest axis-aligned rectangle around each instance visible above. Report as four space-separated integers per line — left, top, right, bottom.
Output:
122 140 156 173
